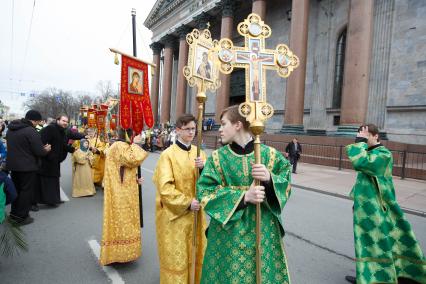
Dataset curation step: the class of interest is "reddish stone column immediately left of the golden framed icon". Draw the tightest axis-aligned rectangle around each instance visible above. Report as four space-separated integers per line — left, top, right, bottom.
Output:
176 26 191 118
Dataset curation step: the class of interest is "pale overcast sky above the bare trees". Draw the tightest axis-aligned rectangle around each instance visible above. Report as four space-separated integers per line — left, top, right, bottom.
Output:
0 0 156 116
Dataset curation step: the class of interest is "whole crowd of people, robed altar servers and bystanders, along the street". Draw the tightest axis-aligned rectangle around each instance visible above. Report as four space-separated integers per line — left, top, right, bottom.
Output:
0 106 426 283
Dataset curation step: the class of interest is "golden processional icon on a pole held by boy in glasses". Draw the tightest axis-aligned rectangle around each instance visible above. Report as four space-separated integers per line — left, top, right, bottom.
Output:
183 24 220 284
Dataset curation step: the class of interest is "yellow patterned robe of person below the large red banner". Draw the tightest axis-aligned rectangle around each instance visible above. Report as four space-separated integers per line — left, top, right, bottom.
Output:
100 141 148 265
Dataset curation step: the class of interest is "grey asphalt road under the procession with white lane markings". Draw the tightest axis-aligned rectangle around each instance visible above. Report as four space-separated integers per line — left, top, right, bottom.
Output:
0 153 426 284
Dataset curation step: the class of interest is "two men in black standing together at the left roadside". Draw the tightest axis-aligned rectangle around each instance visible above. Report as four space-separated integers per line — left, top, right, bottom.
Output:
3 110 84 225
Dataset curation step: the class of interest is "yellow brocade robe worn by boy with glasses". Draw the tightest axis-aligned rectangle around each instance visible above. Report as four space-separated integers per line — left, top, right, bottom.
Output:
153 144 206 284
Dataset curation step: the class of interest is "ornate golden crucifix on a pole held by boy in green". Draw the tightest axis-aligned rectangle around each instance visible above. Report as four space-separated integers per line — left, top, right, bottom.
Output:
211 14 299 283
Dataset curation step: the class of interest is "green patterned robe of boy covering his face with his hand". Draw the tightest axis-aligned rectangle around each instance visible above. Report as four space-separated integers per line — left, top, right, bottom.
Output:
346 142 426 284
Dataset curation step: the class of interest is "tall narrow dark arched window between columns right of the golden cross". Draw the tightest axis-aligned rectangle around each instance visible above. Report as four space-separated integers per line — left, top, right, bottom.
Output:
332 27 347 108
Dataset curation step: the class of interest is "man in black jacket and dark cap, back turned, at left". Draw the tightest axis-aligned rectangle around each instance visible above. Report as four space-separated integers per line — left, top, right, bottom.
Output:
6 110 51 225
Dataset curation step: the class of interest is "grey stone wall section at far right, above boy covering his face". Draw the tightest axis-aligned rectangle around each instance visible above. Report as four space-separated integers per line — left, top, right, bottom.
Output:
385 0 426 144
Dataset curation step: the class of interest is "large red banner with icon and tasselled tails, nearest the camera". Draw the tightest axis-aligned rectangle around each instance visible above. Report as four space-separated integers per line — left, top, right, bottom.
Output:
120 55 154 130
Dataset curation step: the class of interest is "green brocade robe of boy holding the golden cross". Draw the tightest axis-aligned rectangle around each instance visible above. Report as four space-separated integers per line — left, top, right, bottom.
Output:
197 145 290 284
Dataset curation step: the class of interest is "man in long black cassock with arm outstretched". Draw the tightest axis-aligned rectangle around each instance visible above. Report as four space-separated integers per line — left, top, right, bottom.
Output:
38 115 85 207
